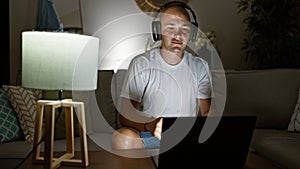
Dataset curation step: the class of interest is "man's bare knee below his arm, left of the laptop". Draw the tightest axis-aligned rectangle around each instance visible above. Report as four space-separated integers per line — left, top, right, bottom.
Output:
112 128 143 149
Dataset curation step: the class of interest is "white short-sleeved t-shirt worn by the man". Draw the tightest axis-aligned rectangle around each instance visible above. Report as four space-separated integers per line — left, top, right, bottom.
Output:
121 48 212 118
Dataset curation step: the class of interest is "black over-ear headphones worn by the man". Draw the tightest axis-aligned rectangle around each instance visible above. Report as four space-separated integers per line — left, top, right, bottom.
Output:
152 1 198 41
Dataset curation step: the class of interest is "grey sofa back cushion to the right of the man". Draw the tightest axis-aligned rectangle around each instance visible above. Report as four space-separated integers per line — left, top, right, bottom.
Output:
224 69 300 129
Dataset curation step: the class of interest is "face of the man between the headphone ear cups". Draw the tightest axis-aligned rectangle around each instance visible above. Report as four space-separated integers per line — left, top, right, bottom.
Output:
161 8 191 53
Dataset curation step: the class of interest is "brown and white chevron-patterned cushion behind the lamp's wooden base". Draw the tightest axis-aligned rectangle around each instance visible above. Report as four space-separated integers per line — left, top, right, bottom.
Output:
3 85 42 142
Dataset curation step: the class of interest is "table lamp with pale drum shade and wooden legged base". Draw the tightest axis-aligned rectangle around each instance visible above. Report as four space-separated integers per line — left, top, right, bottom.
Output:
22 31 99 169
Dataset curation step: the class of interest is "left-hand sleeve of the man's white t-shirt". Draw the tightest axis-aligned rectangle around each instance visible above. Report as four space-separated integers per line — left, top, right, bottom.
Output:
120 58 148 102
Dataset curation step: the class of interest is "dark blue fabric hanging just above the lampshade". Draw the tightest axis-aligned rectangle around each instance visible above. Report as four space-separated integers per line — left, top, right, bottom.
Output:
37 0 63 32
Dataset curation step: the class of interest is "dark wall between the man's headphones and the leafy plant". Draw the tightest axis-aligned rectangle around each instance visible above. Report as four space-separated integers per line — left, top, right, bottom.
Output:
190 0 251 69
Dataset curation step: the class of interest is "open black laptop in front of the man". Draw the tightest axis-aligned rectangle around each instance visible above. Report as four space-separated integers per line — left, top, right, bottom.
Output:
152 116 256 169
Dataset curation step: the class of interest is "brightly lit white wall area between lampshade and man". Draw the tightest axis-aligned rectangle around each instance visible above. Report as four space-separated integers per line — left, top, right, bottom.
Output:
81 0 151 70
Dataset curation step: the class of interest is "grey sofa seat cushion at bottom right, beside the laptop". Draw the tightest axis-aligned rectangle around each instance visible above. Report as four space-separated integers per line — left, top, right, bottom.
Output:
251 129 300 169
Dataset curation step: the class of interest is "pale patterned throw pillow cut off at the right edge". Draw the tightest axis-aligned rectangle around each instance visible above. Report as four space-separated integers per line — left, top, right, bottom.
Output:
288 88 300 132
